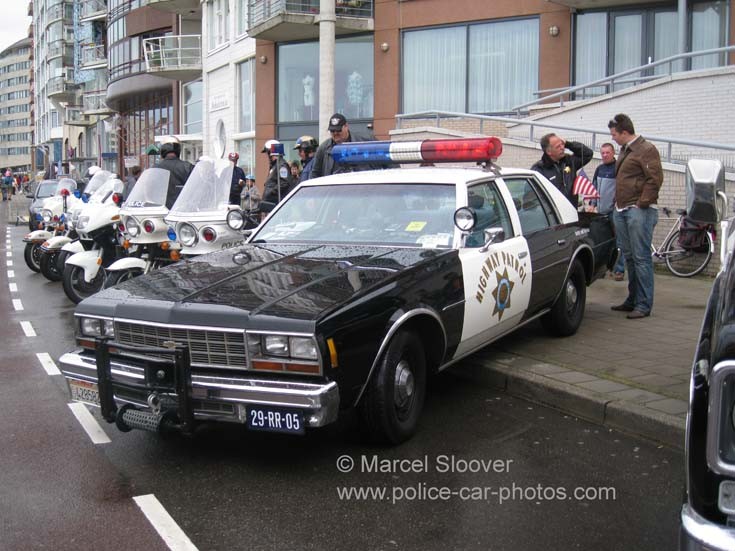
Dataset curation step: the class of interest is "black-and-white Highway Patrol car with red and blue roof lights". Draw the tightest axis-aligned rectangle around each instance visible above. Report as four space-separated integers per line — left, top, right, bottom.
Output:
60 138 617 444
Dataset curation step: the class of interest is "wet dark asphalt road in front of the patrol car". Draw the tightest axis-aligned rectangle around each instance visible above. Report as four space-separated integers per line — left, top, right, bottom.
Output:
0 221 684 551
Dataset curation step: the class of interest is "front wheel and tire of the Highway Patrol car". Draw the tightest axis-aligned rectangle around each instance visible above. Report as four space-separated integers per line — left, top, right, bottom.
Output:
360 331 426 445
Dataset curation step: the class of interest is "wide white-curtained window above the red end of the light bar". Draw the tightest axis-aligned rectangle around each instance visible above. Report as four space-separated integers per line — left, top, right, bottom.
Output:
402 18 539 113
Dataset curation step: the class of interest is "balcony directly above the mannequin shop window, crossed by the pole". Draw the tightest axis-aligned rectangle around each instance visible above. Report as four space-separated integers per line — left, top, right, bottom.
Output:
248 0 375 42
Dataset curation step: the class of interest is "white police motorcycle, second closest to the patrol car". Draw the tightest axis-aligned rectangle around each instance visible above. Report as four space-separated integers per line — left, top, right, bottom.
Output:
104 168 179 287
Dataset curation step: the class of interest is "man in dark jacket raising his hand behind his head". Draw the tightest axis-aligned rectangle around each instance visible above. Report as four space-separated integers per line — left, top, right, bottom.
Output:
531 134 592 207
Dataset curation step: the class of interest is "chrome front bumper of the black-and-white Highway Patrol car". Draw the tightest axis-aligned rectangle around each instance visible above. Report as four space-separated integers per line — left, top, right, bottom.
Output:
59 350 339 427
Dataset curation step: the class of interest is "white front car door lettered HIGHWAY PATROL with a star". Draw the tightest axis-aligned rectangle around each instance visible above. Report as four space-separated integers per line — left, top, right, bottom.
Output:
456 181 531 356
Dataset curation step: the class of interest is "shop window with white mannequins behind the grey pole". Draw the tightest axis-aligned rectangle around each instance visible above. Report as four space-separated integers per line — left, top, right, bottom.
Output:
278 36 373 122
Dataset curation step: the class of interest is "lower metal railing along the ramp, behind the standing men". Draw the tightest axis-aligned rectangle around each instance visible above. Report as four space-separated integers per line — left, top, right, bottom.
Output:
396 111 735 170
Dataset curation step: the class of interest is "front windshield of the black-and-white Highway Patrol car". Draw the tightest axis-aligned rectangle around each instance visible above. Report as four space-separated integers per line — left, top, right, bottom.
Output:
253 183 456 248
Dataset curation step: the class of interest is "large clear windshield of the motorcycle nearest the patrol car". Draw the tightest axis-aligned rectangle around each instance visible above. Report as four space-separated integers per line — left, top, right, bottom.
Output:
171 157 233 213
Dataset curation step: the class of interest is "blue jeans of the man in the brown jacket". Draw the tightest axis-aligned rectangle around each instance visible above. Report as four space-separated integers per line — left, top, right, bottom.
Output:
613 207 658 314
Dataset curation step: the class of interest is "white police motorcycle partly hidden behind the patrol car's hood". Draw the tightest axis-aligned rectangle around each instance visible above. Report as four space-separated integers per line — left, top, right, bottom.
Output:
166 157 245 257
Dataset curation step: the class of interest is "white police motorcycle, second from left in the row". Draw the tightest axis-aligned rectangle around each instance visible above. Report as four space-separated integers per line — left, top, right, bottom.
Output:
40 169 113 281
